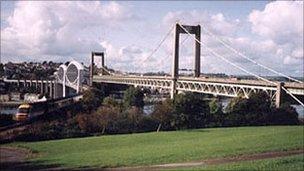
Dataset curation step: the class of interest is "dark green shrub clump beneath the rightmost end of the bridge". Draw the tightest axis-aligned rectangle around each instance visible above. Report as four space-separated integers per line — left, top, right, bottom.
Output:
224 92 299 126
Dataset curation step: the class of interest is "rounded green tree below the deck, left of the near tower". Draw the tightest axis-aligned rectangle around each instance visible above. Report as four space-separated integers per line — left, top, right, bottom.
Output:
123 87 144 108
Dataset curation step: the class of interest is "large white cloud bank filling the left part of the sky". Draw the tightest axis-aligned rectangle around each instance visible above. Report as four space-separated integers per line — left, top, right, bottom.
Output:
1 1 136 60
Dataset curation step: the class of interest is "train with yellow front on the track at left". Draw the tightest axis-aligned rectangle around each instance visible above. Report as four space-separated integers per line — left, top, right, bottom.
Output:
14 95 82 122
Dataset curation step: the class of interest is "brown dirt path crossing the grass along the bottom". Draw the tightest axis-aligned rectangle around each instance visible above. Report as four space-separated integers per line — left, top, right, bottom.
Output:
0 147 304 171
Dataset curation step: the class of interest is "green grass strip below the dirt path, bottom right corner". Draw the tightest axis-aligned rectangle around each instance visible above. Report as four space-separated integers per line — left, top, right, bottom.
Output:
172 154 304 171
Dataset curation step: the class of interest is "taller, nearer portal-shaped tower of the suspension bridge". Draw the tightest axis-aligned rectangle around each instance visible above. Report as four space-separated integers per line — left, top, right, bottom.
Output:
171 23 201 99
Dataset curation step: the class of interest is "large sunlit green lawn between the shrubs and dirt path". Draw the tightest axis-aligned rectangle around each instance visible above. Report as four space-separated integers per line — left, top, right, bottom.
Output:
4 126 304 167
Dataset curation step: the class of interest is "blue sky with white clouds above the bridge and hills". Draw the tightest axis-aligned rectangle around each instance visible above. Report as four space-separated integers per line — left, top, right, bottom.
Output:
1 1 304 76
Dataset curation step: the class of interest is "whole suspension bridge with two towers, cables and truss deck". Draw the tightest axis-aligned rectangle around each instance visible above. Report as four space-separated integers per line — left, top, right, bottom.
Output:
90 23 304 107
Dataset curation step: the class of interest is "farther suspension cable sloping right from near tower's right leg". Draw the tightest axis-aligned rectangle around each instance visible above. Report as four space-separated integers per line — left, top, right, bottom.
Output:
202 26 303 83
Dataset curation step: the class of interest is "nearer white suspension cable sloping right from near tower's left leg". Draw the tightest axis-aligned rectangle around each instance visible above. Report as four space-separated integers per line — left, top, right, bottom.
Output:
177 23 304 107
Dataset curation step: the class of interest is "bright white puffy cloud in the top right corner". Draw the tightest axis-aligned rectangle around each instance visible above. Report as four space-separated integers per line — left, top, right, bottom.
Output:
248 1 303 43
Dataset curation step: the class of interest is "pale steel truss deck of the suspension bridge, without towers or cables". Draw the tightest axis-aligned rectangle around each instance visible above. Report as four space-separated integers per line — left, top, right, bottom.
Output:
93 75 304 100
